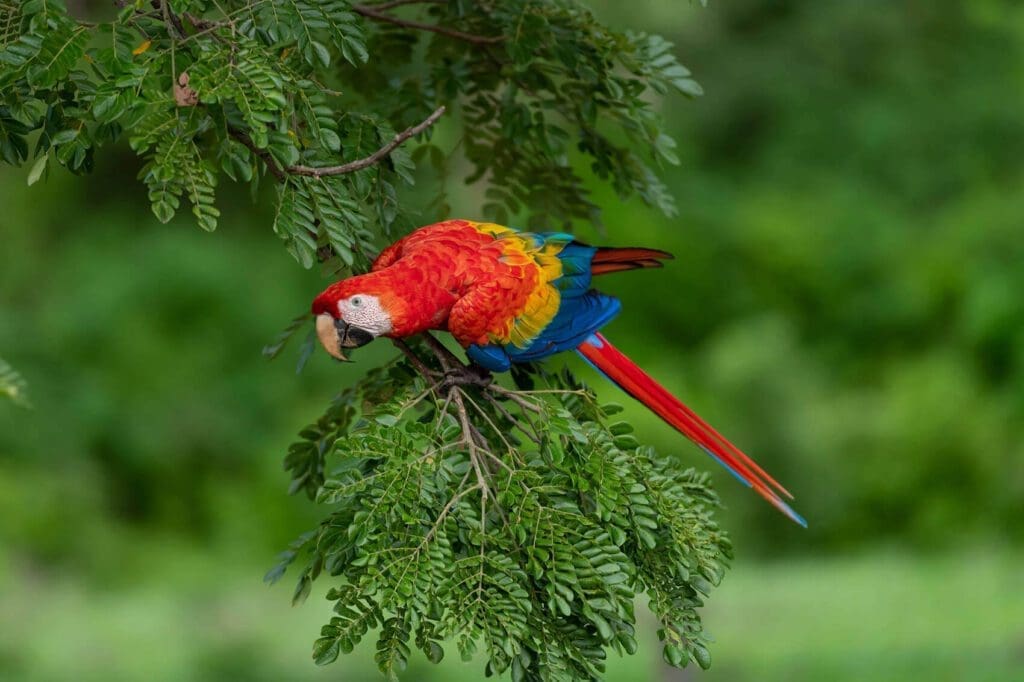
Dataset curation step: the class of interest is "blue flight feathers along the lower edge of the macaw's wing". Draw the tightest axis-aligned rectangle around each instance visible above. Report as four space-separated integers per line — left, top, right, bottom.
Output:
466 291 622 372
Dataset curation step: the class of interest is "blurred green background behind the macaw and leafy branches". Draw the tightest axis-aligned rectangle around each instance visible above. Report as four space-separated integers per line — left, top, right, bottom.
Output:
0 0 1024 682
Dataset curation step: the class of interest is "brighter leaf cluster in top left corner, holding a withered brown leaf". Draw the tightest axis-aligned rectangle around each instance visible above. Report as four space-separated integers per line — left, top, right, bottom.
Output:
0 0 403 266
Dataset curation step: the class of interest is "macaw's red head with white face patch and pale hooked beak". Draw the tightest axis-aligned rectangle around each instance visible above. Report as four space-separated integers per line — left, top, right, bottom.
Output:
312 274 400 360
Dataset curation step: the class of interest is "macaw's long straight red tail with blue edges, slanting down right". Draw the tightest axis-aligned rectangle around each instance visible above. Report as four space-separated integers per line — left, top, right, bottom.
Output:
577 333 807 528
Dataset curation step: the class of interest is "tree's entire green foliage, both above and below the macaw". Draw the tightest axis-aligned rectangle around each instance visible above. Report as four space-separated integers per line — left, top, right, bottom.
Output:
0 0 729 680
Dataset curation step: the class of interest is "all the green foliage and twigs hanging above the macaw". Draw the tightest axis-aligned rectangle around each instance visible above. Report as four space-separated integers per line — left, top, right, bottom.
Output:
0 0 699 268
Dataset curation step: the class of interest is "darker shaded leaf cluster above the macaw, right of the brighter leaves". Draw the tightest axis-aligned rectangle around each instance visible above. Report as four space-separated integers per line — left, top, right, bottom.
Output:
346 0 701 227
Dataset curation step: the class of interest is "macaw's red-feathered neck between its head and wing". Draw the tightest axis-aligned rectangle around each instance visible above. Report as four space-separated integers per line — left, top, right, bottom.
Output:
364 261 458 338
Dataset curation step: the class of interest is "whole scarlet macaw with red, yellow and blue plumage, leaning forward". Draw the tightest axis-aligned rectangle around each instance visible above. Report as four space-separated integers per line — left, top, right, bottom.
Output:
312 220 807 526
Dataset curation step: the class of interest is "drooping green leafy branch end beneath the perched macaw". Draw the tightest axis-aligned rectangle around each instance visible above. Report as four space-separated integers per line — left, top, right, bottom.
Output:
268 348 730 680
